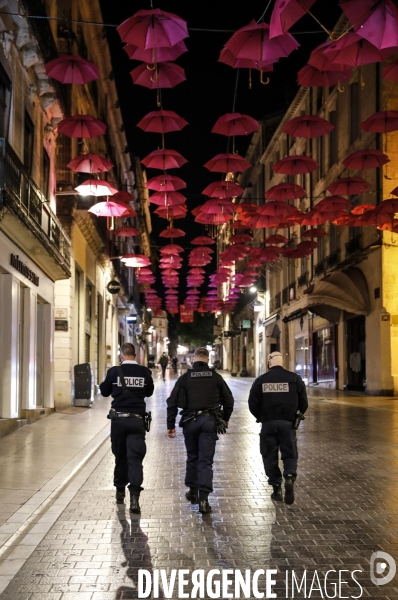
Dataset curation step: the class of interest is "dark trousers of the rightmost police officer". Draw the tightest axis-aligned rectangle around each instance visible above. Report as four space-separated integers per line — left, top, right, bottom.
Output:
260 421 298 485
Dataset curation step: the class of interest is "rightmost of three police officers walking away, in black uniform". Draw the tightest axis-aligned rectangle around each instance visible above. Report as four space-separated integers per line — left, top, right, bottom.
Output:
249 352 308 504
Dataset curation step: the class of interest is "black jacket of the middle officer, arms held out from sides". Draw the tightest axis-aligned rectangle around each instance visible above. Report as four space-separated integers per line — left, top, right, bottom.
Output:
167 361 234 429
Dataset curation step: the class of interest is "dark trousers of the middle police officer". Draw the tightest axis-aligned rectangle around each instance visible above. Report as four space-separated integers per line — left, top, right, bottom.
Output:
183 415 218 494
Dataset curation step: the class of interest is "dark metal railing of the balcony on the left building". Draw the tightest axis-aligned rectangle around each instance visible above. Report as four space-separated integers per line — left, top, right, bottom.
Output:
0 138 71 271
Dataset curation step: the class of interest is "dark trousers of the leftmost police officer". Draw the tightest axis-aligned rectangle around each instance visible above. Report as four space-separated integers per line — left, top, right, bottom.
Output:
111 417 146 496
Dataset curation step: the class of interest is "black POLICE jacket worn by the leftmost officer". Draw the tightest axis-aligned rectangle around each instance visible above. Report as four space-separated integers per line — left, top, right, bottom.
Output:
100 362 154 415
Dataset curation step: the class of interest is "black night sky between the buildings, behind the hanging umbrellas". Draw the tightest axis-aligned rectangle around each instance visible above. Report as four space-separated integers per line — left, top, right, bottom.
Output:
100 0 341 300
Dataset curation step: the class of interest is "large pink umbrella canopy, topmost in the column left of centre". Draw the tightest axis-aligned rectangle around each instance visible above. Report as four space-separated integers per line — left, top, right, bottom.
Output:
117 8 188 49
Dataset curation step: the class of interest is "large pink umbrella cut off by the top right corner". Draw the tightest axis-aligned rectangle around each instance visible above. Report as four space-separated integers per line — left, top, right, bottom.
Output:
340 0 398 49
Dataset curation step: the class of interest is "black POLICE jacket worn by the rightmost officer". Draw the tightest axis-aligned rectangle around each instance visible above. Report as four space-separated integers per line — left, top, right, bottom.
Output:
249 367 308 423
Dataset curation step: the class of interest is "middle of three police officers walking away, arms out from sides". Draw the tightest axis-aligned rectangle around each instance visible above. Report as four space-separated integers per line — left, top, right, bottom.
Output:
167 348 234 513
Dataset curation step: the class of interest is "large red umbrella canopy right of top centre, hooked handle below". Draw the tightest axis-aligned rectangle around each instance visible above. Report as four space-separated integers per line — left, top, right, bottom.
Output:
225 23 300 63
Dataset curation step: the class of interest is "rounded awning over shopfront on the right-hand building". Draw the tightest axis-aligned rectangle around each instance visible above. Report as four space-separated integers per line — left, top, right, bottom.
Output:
307 267 371 323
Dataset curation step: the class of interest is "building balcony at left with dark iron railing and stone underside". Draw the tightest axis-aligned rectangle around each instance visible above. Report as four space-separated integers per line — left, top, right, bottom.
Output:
0 138 71 281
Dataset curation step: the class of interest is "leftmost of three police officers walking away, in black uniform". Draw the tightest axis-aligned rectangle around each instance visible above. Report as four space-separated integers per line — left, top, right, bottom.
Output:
100 344 154 513
